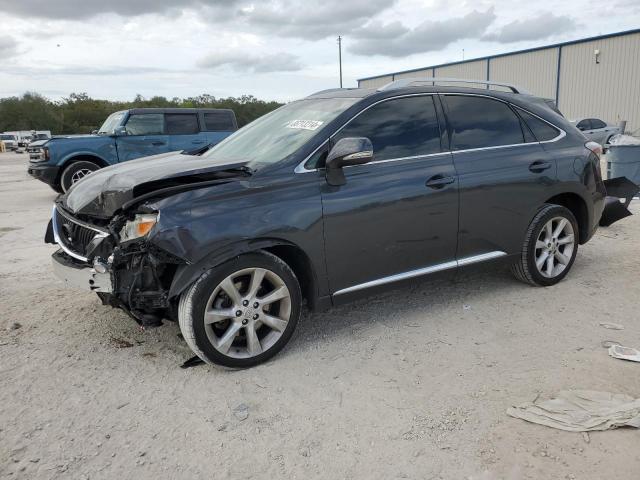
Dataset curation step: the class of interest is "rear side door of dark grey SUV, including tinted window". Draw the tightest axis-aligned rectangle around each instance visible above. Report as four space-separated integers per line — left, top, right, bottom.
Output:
442 94 556 263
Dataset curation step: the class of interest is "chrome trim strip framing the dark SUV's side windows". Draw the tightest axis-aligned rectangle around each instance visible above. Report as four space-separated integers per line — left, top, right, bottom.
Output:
293 92 567 173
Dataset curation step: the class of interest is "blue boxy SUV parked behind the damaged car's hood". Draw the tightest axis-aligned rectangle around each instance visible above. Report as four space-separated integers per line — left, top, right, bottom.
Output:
28 108 238 192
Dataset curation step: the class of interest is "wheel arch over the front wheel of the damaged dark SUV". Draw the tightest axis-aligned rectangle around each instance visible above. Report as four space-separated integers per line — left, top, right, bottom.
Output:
169 238 319 309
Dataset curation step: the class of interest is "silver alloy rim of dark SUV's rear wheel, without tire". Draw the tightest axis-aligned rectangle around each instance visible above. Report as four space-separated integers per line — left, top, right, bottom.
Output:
535 217 576 278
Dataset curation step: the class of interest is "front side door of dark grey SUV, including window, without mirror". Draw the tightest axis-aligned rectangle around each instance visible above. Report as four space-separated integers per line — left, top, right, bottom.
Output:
322 95 458 295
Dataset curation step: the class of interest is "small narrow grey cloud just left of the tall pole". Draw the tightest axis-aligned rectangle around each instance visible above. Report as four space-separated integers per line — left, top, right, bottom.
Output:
198 51 302 73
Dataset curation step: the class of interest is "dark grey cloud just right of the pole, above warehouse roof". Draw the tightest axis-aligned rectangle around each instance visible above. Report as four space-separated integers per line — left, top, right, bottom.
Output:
349 7 496 57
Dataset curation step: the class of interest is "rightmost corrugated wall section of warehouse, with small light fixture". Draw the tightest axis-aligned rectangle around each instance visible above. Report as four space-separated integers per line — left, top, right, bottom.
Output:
558 33 640 134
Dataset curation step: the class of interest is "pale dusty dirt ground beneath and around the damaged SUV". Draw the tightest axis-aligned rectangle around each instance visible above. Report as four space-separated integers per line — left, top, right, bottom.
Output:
0 153 640 480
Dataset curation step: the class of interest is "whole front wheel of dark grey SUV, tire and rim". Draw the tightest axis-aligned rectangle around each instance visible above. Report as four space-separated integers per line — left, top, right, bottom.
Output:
178 252 302 368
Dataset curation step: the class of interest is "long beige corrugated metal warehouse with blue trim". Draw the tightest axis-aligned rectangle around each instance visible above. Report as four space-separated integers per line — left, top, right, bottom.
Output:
358 29 640 134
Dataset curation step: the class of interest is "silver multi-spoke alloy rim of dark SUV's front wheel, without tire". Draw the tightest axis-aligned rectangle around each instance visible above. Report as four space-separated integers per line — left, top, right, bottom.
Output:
204 268 291 358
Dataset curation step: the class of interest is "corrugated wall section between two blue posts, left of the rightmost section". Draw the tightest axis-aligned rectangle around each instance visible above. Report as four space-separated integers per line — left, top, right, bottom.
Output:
489 48 558 99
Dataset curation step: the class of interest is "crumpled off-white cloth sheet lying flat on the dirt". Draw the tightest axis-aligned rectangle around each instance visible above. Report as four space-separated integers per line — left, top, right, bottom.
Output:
507 390 640 432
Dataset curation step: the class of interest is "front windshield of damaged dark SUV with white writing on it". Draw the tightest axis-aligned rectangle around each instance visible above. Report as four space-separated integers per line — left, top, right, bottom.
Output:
204 98 359 166
